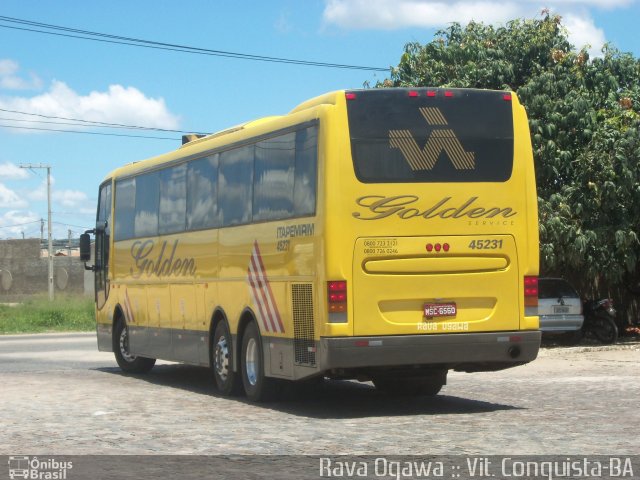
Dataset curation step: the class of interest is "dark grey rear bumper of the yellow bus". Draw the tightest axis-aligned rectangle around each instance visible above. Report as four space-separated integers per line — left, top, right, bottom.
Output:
319 330 541 372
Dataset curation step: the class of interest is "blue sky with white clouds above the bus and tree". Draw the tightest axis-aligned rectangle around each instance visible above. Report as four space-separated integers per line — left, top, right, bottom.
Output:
0 0 640 239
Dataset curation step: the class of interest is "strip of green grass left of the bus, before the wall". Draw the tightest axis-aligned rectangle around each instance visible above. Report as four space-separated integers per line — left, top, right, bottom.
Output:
0 296 95 335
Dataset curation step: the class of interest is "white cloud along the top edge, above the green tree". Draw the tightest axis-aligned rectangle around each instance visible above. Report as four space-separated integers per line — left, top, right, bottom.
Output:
323 0 636 56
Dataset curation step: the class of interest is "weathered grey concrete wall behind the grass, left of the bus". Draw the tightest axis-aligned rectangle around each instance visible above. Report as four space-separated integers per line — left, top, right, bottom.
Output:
0 239 93 302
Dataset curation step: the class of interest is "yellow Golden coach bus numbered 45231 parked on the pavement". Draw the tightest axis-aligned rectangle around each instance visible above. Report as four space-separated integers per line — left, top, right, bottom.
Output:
81 88 540 401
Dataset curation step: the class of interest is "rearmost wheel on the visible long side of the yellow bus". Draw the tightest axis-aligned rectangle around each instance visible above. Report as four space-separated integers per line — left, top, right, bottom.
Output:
241 322 277 402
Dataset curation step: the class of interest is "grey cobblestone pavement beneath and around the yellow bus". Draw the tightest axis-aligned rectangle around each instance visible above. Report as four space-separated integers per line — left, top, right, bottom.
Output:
0 334 640 455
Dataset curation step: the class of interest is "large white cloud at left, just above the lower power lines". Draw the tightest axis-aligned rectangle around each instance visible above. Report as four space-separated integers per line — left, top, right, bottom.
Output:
0 81 179 129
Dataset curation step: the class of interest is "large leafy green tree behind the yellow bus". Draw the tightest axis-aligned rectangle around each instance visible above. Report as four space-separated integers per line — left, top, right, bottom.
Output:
377 11 640 312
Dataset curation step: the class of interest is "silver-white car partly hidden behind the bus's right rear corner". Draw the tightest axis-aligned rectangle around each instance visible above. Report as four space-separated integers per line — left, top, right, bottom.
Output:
538 278 584 340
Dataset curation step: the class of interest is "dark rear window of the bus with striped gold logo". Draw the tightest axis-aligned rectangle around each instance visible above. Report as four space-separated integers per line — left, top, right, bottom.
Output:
347 88 513 183
